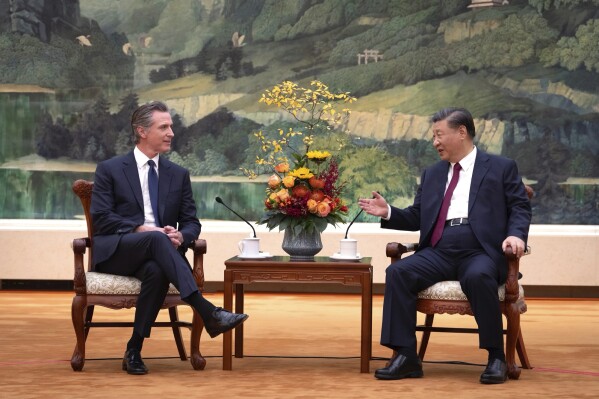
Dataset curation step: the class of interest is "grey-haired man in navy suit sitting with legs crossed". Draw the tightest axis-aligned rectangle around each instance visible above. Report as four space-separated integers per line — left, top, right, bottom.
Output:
91 101 248 374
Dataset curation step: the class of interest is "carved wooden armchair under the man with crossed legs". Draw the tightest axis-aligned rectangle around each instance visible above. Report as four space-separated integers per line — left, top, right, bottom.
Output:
71 180 206 371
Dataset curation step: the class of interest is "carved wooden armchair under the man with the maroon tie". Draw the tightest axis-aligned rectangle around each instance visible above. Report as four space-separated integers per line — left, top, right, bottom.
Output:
387 186 533 380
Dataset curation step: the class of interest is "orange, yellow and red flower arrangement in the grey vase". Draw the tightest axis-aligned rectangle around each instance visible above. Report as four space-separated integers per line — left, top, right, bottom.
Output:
243 80 356 235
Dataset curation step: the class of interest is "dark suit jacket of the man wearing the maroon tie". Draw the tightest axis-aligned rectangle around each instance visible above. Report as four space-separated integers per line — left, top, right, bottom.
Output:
381 150 532 282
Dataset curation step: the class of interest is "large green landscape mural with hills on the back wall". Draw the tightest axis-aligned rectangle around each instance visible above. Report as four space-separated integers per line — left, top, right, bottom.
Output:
0 0 599 224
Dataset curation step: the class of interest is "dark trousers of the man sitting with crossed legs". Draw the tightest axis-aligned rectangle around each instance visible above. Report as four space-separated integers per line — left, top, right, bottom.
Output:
95 231 198 337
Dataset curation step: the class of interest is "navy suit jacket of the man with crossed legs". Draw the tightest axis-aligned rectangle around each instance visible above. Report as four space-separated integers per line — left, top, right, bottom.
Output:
91 152 201 265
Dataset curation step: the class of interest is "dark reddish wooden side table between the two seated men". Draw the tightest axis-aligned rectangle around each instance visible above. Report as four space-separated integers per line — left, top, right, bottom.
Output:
223 256 372 373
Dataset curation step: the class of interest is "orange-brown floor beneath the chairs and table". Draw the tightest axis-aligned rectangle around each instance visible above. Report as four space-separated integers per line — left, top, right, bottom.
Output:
0 291 599 398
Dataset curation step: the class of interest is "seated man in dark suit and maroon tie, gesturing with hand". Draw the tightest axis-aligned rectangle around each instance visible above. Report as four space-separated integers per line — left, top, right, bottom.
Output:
359 108 531 384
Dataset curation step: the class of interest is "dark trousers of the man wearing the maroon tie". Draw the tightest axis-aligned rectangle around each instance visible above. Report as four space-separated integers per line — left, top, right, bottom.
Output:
381 225 503 352
